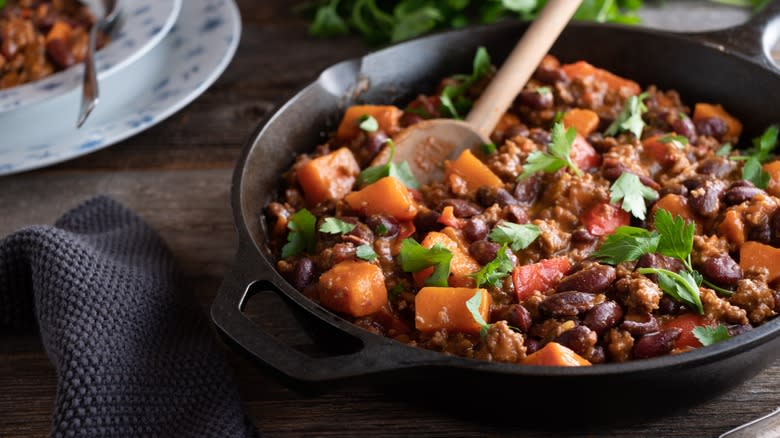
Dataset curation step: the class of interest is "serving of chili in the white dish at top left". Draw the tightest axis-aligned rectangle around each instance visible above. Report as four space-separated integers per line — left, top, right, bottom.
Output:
0 0 108 89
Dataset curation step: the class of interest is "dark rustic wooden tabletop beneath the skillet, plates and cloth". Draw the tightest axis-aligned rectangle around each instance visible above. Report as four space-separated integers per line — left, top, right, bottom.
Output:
0 0 780 437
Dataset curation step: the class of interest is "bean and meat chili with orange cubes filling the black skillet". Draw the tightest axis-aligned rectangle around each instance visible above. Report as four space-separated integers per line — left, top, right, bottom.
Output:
264 49 780 366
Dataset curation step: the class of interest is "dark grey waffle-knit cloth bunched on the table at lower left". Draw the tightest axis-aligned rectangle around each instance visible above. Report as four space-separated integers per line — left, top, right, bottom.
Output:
0 197 257 437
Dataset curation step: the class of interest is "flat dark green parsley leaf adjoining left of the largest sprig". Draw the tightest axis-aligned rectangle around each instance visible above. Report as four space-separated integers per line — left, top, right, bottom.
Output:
592 226 661 265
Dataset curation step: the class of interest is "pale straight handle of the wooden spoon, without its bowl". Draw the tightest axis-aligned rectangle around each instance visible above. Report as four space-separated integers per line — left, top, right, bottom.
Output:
466 0 582 138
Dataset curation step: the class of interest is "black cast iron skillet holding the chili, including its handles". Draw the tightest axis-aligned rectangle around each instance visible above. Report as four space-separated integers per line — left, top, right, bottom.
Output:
211 1 780 418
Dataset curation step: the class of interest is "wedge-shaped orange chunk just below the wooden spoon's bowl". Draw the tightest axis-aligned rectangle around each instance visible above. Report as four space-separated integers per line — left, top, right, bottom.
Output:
344 176 417 221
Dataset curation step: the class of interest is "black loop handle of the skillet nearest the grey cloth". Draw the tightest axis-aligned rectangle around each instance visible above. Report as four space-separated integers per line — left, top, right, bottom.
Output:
211 243 443 383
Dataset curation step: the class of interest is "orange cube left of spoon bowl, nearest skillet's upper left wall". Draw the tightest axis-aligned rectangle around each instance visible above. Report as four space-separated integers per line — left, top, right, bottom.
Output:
296 148 360 206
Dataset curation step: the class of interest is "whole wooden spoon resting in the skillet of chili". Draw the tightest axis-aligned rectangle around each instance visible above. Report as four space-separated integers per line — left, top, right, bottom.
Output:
394 0 581 184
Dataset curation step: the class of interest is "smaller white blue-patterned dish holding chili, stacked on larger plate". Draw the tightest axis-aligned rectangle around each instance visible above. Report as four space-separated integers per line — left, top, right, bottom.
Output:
0 0 182 112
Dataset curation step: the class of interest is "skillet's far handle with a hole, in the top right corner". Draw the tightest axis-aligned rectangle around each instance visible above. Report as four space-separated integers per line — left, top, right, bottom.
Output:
691 0 780 70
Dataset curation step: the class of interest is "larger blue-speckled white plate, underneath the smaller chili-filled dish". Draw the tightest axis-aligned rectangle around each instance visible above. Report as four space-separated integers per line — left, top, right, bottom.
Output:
0 0 241 175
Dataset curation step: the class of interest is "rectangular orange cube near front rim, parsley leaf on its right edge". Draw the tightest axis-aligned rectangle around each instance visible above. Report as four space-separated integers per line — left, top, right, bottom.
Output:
414 287 491 334
